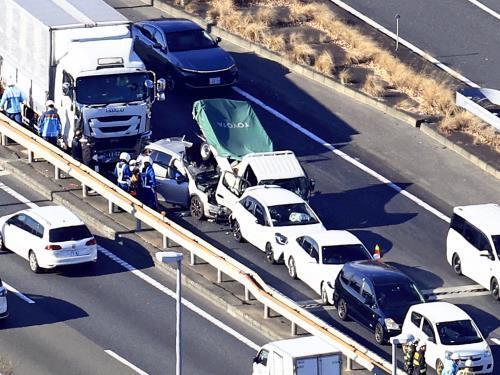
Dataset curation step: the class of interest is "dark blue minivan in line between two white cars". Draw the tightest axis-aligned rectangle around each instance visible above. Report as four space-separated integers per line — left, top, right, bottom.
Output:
333 260 425 344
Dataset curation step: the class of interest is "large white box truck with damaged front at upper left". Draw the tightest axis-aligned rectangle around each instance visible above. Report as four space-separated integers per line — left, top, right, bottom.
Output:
0 0 166 163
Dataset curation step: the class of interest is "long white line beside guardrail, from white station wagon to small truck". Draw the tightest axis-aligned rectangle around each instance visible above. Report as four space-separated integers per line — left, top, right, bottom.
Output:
98 246 259 350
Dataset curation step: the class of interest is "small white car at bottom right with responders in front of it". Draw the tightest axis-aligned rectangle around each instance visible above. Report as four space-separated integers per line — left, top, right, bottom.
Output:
402 302 493 374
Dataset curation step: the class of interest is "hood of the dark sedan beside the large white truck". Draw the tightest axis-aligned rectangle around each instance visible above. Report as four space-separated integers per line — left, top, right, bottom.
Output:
170 47 234 72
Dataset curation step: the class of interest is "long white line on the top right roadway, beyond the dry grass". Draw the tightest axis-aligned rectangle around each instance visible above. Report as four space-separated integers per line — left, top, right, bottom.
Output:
330 0 480 88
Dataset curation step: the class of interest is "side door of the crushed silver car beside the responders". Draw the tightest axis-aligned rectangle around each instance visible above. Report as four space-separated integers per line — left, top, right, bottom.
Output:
150 151 189 207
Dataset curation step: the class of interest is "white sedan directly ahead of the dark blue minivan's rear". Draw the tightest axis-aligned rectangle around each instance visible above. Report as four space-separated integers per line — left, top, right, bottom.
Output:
283 230 373 305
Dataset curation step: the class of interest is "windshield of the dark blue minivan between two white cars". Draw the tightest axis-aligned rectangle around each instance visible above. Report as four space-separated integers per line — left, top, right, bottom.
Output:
375 282 425 308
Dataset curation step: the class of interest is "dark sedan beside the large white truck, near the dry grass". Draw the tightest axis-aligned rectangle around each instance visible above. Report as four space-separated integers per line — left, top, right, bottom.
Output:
132 18 238 88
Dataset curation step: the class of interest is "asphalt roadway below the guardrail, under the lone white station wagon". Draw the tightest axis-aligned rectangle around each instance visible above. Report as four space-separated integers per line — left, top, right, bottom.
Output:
0 175 266 375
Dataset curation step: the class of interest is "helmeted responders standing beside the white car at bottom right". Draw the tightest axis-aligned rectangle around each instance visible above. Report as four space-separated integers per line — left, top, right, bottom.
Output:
403 339 474 375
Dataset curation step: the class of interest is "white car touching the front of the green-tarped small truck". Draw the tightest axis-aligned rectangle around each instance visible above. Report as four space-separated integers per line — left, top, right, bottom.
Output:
230 185 326 263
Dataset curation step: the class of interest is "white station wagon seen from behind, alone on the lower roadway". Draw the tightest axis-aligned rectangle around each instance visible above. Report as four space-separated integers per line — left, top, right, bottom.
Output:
0 206 97 272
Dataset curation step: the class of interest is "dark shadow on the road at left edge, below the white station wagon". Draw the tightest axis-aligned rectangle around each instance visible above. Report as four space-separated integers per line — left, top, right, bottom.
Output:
0 293 88 330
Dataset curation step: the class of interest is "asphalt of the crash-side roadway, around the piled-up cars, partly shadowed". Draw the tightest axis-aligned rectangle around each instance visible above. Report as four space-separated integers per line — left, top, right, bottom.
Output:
106 0 500 370
